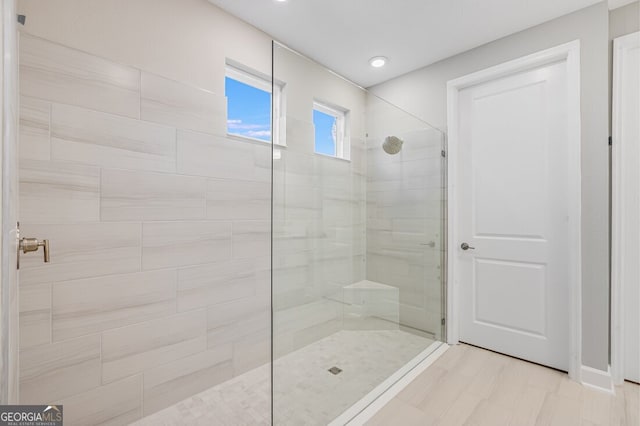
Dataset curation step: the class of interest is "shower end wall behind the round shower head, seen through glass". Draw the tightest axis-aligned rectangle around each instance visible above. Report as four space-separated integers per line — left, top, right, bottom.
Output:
366 95 445 339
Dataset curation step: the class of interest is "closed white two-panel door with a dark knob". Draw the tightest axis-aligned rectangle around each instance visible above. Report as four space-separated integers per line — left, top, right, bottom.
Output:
451 50 575 371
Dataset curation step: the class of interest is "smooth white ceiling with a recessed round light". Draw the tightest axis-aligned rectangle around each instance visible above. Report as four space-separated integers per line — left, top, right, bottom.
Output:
209 0 600 87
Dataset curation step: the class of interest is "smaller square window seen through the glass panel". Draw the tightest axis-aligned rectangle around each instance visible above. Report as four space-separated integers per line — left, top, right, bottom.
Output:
313 102 349 159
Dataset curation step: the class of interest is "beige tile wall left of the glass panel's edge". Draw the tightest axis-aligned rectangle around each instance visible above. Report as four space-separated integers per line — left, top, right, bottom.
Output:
15 33 271 426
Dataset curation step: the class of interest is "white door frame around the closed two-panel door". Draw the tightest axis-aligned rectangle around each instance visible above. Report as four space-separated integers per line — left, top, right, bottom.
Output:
447 40 582 381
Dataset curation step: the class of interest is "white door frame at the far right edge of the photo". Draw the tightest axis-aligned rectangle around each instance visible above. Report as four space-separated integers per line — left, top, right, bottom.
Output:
611 32 640 384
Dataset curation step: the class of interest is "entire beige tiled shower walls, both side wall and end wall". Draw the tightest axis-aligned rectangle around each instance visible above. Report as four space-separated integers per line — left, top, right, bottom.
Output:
19 28 442 425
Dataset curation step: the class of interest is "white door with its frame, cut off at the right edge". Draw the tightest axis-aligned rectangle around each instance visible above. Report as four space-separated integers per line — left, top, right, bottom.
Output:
612 33 640 382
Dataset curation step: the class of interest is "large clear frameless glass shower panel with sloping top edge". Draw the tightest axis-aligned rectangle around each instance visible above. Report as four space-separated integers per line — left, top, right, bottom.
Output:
272 43 443 425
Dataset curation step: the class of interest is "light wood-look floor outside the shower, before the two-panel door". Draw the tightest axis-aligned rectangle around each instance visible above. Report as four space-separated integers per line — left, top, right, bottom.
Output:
368 345 640 426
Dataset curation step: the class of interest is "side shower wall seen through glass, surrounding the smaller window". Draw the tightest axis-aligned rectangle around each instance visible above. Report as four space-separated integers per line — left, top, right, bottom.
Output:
272 48 366 358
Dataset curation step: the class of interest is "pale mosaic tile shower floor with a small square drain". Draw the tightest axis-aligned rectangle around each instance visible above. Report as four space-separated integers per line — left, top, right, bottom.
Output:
134 330 433 426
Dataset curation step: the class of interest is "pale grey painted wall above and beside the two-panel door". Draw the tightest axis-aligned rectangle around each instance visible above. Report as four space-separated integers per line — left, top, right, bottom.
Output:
372 2 609 370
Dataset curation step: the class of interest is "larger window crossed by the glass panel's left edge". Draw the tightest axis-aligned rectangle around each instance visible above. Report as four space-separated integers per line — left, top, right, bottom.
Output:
225 64 284 145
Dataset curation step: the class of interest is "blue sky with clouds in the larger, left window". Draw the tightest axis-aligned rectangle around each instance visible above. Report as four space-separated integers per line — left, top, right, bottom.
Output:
225 77 271 142
